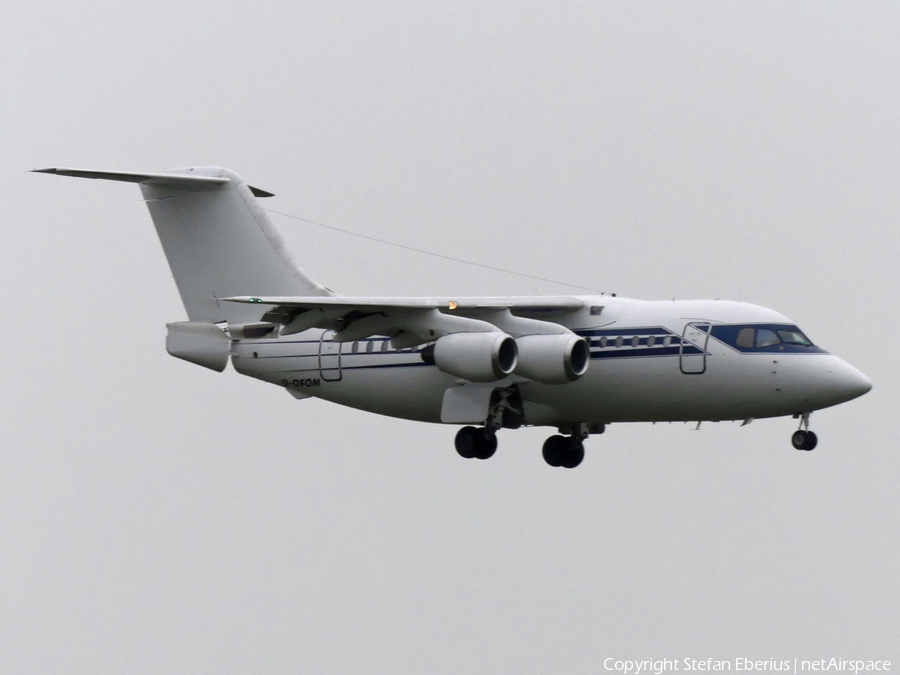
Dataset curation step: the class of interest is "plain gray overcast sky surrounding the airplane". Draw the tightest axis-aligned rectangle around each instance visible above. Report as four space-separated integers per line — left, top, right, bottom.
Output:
0 0 900 673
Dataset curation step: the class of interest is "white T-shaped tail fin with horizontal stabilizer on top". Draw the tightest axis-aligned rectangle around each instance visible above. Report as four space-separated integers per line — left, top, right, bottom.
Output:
38 167 334 323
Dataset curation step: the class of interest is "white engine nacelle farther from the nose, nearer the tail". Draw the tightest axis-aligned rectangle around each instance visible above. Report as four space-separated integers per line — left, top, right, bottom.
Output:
422 333 517 382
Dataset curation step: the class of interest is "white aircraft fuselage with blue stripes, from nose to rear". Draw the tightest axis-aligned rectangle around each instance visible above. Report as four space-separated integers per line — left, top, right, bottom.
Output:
232 296 871 426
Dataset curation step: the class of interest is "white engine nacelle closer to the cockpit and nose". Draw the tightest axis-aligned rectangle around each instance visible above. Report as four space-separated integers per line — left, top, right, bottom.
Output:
516 335 591 384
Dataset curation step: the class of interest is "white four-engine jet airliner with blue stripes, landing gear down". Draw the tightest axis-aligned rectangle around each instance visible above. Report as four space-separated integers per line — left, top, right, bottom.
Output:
37 167 872 468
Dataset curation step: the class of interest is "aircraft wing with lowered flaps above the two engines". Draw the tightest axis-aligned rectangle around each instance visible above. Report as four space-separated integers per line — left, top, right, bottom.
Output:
224 296 585 347
